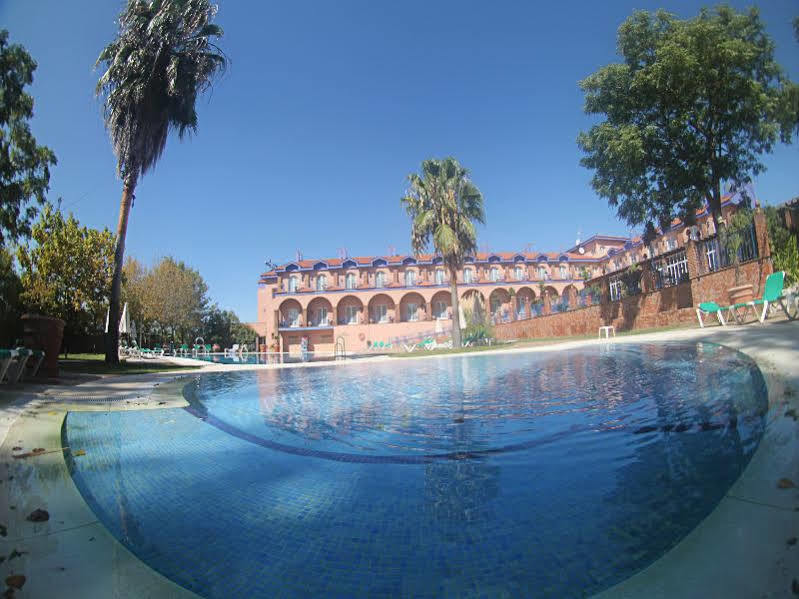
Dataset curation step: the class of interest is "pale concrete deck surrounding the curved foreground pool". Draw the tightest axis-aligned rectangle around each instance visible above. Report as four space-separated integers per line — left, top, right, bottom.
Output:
0 321 799 598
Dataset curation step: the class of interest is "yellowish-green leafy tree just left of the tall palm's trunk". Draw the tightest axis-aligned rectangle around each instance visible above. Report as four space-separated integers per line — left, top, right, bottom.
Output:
17 204 114 334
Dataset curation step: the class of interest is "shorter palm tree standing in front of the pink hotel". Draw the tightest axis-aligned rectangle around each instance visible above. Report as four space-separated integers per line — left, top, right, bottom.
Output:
402 157 485 347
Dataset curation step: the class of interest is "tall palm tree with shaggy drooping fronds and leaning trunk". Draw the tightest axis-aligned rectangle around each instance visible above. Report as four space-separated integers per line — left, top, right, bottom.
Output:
95 0 226 363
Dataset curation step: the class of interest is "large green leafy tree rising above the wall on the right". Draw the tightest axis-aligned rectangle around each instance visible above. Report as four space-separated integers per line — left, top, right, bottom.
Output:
577 5 790 228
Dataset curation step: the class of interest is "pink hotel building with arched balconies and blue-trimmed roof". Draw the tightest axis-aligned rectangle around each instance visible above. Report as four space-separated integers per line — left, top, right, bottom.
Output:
251 199 734 353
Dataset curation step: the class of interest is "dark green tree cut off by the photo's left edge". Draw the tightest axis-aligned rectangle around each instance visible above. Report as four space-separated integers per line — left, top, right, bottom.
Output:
0 29 56 249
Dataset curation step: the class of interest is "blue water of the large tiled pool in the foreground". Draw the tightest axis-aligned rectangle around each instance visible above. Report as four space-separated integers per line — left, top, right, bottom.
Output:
63 343 767 597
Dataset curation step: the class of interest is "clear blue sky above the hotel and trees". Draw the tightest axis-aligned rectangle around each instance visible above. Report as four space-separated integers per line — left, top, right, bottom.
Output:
0 0 799 320
